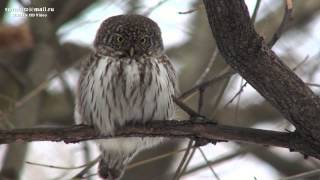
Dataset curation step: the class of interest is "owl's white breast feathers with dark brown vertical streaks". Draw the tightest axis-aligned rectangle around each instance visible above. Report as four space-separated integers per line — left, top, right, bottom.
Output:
80 58 174 133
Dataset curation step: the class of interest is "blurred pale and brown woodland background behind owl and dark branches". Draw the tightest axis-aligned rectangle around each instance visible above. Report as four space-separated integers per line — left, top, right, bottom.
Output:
0 0 320 180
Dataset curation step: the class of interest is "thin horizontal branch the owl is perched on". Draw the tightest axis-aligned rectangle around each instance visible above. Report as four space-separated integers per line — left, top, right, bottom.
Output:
0 120 312 155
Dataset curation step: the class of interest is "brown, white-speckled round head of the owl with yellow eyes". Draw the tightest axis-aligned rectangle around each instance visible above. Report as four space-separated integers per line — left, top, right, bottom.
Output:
94 15 163 58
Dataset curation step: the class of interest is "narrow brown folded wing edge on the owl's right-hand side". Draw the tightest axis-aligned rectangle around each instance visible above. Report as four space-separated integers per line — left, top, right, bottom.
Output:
160 55 180 97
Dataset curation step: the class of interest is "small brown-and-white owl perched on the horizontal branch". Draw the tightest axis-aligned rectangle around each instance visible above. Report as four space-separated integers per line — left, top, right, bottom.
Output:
75 15 177 179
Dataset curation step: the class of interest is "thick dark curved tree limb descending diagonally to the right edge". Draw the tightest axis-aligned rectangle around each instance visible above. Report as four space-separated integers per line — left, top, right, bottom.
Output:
203 0 320 157
